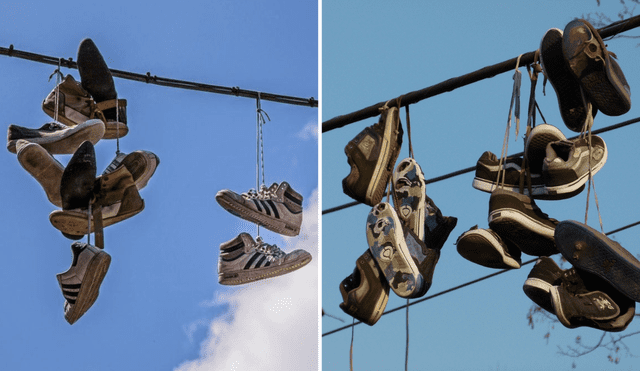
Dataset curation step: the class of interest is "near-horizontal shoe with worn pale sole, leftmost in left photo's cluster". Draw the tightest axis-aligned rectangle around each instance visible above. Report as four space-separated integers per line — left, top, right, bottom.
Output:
7 120 104 155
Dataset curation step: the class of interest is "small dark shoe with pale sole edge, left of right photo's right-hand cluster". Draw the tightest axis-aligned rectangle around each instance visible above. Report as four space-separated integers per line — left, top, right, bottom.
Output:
456 225 522 269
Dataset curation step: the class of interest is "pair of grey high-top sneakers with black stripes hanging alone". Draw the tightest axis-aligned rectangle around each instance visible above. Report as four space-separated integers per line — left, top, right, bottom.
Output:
216 182 311 285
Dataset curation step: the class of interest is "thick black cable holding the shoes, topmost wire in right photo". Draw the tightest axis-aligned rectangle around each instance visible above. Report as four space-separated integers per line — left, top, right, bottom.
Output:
322 15 640 133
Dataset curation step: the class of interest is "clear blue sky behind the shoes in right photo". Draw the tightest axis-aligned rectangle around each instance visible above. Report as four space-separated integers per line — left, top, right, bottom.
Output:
322 0 640 370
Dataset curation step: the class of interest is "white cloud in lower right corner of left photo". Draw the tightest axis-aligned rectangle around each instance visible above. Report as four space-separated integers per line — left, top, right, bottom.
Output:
175 190 318 371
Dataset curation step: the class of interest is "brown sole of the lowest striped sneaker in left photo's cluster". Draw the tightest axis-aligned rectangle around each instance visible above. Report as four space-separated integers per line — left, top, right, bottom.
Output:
58 251 111 325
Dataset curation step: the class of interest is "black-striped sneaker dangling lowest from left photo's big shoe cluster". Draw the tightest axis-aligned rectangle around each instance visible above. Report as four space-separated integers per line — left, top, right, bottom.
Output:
57 242 111 325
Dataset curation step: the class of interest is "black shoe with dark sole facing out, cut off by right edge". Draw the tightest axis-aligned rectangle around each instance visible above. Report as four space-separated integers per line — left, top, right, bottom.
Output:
555 220 640 302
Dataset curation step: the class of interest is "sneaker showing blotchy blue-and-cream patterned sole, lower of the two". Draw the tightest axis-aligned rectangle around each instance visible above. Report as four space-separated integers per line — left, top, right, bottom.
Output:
367 202 423 298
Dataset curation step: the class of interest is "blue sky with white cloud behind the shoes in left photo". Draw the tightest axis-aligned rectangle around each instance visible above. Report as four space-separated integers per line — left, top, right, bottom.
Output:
0 0 319 370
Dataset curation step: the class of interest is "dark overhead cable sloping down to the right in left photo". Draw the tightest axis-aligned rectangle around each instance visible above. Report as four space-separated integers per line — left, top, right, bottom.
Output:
0 44 318 107
